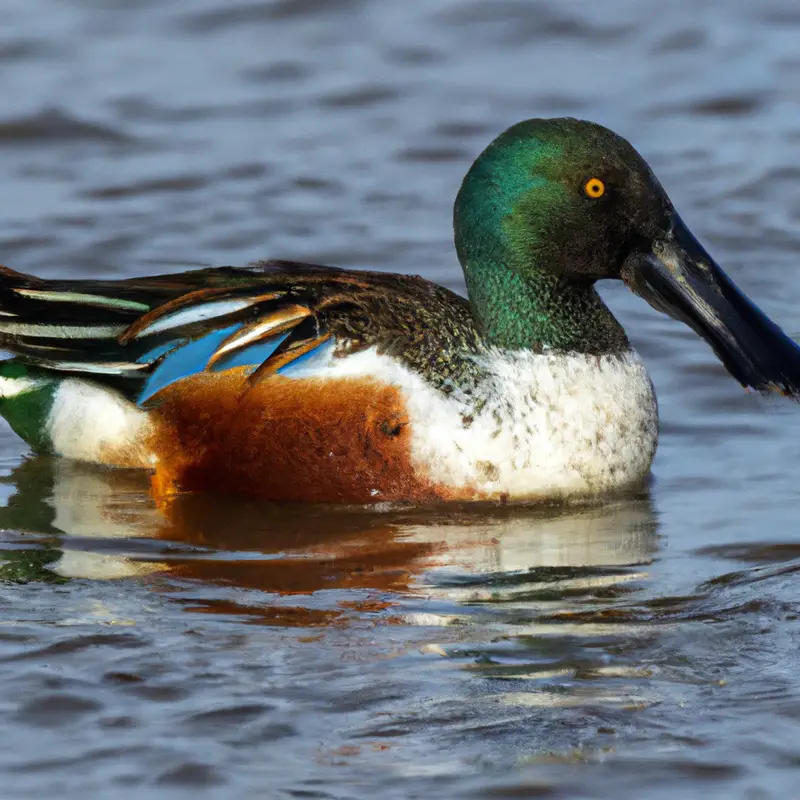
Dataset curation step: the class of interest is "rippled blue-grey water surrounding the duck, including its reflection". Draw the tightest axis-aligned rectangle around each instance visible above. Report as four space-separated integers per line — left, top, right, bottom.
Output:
0 0 800 800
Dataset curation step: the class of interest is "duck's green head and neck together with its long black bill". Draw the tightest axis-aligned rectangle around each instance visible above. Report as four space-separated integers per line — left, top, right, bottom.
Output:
454 119 800 394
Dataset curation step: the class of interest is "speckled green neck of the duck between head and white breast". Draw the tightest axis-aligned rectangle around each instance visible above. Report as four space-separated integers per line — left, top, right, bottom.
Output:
459 252 630 355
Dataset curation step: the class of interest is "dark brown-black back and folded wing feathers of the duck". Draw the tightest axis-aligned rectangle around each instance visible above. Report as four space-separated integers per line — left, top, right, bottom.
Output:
0 261 481 398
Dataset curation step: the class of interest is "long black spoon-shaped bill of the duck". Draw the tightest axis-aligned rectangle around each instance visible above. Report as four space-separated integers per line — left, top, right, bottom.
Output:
622 214 800 398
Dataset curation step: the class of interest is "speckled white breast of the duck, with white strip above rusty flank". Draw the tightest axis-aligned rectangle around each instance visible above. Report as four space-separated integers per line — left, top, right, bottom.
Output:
317 350 658 500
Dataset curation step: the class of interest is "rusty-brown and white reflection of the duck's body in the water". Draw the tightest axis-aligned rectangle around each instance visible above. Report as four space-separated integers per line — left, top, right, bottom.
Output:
0 458 657 626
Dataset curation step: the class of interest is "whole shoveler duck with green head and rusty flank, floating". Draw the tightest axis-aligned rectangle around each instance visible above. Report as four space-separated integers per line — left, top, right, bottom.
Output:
0 119 800 503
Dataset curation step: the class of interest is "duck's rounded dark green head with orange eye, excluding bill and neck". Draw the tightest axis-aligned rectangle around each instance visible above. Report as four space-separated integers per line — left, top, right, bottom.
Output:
455 119 672 281
